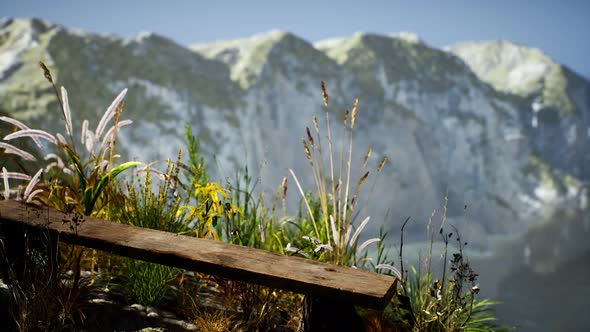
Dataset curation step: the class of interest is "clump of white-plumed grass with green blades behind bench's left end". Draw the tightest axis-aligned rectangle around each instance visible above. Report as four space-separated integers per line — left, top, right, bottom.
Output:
0 62 142 215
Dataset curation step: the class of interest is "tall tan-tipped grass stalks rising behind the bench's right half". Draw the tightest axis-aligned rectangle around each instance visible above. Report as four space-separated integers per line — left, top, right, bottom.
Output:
289 82 394 266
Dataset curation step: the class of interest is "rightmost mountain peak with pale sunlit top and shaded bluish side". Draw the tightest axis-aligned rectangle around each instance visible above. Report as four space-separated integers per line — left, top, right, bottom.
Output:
448 41 590 180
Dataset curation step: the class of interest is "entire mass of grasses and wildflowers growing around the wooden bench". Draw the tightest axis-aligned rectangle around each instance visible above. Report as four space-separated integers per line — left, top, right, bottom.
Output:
0 63 508 331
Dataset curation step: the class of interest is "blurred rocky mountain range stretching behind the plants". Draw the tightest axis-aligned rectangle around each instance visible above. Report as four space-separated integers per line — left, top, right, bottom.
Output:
0 19 590 248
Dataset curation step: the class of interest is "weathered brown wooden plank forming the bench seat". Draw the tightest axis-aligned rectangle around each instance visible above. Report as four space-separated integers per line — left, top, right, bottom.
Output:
0 201 395 309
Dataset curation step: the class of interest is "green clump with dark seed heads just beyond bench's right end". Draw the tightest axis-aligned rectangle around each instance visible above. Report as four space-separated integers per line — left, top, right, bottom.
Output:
394 201 509 331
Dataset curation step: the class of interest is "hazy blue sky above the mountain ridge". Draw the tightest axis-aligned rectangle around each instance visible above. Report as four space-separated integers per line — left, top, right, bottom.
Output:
0 0 590 78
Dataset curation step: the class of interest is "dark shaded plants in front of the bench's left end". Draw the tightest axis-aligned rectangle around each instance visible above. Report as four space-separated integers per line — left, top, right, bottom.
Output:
0 228 90 331
